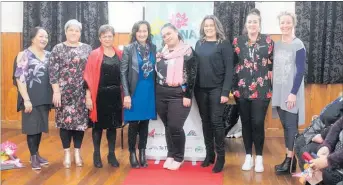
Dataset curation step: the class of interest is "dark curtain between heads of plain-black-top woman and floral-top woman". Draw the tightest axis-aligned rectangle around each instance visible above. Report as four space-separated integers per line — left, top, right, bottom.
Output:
214 1 255 42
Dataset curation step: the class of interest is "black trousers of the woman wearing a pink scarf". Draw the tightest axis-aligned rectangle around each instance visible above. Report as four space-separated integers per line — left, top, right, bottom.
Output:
156 85 191 162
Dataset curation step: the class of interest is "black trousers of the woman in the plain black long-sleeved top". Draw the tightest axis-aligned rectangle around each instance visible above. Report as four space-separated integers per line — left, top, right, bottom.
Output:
194 87 225 156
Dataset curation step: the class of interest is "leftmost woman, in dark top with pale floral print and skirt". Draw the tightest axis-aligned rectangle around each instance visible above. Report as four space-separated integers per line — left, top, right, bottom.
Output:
14 27 52 170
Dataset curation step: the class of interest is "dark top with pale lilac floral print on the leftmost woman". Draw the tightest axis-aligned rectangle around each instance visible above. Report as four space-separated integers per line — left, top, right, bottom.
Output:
14 49 52 110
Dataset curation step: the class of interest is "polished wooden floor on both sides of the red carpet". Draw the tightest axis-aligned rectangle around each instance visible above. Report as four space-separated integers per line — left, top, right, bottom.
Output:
1 129 300 185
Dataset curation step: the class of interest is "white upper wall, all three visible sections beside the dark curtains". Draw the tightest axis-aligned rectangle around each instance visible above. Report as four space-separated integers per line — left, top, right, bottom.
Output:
1 2 295 34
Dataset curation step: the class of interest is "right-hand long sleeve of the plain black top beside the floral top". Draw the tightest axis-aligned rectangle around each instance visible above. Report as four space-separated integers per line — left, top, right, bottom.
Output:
221 41 234 97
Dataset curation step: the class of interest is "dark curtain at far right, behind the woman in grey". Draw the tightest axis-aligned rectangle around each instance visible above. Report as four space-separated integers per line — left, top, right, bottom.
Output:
295 1 343 84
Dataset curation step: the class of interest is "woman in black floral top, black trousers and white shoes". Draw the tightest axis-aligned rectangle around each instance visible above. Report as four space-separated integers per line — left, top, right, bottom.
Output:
233 9 274 172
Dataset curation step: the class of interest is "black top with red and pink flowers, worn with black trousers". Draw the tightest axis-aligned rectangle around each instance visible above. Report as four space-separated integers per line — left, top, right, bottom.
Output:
232 34 274 99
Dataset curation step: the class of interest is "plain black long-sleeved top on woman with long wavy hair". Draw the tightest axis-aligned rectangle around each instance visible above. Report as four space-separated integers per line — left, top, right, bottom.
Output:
195 40 233 97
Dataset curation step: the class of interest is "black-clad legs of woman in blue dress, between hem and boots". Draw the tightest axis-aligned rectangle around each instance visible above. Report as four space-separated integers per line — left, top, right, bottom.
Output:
128 120 149 152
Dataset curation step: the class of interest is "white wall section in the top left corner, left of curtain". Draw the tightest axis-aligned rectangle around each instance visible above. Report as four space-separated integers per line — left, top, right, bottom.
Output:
1 2 23 32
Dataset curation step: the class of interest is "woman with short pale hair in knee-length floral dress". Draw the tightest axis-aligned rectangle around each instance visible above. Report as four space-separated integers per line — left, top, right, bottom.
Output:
49 19 92 168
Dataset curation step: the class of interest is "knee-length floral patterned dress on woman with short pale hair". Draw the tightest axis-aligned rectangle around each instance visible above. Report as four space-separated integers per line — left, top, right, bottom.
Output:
49 43 92 131
